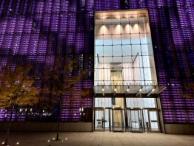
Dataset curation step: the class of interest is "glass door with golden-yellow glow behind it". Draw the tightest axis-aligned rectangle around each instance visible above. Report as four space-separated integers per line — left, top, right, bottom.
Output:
112 108 124 132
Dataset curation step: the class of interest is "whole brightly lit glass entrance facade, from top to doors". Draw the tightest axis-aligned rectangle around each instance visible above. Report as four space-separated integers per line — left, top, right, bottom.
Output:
94 10 160 132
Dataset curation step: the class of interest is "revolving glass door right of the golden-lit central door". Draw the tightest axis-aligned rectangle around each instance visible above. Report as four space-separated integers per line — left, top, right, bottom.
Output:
128 109 144 132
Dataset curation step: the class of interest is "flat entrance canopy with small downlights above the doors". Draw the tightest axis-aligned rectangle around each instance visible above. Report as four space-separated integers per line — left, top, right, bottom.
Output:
94 85 166 98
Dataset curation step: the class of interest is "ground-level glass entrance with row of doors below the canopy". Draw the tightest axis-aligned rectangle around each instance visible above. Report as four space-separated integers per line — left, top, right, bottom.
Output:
94 97 161 133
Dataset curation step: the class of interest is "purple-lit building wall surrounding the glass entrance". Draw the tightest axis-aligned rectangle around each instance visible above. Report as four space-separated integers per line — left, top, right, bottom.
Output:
0 0 194 123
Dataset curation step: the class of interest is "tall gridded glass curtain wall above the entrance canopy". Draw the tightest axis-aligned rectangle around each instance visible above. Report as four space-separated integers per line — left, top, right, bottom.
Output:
94 10 157 86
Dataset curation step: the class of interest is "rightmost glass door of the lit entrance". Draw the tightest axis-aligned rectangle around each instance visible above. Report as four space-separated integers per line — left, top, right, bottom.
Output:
148 110 160 132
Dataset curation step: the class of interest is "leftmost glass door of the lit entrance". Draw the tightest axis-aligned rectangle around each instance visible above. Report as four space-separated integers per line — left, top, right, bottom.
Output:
94 108 105 131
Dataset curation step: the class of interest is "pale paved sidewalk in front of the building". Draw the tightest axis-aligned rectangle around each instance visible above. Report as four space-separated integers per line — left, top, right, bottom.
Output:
0 132 194 146
